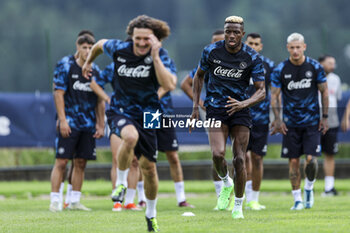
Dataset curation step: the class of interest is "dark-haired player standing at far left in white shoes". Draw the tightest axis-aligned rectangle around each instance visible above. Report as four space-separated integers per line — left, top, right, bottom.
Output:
50 34 104 212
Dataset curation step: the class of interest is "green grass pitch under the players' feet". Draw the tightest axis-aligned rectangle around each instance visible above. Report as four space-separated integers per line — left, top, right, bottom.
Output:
0 180 350 233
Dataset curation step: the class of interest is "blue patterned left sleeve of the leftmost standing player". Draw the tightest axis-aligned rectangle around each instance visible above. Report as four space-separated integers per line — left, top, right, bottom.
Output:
53 57 71 91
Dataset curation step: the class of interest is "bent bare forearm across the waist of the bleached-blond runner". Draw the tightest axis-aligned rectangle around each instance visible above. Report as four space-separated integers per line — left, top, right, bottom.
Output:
225 81 266 116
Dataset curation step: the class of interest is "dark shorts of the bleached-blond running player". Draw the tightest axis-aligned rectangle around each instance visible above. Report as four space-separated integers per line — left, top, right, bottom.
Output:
206 105 252 129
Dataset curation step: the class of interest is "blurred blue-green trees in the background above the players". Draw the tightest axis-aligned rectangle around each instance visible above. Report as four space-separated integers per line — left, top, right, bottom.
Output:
0 0 350 92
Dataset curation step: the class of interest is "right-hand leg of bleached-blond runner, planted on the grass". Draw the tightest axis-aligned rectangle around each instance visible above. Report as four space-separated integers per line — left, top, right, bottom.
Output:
230 125 250 219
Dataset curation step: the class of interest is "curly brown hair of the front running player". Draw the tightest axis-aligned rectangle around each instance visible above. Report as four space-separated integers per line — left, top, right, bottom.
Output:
126 15 170 40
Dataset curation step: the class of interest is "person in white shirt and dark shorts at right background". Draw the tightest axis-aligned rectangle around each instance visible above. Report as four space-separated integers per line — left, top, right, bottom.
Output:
318 55 342 196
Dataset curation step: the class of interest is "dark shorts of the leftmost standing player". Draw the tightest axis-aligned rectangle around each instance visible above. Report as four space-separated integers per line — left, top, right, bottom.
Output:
55 129 96 160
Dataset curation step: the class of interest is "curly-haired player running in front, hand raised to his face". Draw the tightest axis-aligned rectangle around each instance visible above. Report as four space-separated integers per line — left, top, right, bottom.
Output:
83 15 176 231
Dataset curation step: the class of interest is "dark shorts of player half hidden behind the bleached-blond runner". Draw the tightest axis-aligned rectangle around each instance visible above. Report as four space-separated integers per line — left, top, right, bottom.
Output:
248 125 269 156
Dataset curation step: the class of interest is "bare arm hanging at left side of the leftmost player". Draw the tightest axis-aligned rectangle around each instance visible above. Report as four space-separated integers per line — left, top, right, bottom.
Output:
54 90 72 138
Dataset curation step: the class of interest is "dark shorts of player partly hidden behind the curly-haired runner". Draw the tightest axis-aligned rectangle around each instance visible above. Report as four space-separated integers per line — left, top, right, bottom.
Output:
156 127 179 152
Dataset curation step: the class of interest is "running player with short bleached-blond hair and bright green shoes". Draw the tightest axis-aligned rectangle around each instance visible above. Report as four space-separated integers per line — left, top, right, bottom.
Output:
190 16 265 219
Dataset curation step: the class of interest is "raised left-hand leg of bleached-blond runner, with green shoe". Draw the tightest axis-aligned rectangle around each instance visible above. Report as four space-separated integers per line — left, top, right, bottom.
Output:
209 124 233 210
